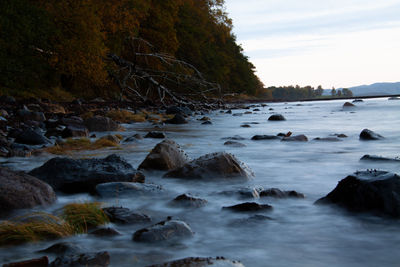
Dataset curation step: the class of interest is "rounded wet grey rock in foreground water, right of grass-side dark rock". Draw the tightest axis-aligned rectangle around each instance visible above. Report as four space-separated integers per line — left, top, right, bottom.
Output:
132 220 193 243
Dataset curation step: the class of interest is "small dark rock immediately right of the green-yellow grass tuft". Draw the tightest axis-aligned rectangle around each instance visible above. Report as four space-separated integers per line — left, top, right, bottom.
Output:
103 207 151 224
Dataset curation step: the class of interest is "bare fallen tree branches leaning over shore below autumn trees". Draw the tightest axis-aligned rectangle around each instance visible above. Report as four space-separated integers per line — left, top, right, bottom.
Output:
108 38 221 108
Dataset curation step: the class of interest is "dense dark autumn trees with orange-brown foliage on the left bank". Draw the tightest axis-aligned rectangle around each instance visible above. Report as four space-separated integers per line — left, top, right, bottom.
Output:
0 0 263 102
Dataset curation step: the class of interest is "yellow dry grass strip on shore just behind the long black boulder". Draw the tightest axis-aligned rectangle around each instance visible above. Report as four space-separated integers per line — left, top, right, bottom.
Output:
45 137 118 155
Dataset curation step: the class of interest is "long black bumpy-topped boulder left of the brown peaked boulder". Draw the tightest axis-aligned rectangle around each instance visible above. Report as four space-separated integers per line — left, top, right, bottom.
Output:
29 154 144 193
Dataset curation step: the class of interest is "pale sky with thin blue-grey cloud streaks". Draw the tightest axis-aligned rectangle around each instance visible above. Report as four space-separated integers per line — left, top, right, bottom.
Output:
225 0 400 88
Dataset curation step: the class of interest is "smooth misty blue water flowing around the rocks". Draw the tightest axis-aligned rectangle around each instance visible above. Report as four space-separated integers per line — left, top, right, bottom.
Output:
0 99 400 267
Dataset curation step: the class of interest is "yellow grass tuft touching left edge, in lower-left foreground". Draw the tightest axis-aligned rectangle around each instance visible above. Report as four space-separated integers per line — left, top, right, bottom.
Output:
0 212 75 246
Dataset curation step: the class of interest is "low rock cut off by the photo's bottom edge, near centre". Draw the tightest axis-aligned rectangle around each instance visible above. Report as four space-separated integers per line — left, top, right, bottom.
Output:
147 257 244 267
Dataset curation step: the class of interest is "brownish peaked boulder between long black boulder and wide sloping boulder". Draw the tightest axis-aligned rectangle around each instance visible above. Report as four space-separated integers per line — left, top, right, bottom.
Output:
139 139 189 171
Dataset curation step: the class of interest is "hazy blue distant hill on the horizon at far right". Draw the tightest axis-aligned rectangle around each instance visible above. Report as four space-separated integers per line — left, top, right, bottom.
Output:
323 82 400 96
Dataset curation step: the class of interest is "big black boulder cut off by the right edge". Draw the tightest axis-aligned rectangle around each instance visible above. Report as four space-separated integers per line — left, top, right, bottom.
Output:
316 170 400 218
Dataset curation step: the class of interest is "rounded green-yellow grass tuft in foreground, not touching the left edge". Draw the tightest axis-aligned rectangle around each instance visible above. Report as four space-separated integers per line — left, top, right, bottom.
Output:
62 202 109 233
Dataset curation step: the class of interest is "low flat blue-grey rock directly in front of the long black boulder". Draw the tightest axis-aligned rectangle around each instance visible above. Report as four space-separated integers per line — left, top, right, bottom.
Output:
96 182 163 198
